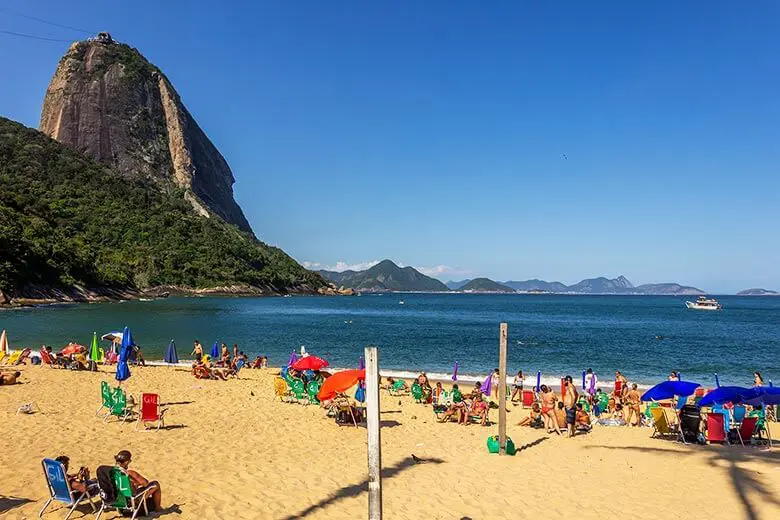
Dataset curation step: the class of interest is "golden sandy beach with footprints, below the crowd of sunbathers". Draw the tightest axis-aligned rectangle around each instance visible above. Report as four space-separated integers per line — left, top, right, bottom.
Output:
0 365 780 519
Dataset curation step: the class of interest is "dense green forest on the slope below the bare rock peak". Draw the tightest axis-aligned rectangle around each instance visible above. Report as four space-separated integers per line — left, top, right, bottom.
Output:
0 118 325 295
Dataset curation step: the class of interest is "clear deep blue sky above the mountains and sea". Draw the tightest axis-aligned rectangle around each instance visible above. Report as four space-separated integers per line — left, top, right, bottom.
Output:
0 0 780 292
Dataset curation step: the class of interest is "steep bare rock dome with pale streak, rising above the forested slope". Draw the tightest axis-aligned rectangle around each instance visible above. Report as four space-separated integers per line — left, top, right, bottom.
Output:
40 41 252 233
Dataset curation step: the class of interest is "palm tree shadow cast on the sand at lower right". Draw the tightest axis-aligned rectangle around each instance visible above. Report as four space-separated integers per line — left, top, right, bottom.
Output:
585 441 780 520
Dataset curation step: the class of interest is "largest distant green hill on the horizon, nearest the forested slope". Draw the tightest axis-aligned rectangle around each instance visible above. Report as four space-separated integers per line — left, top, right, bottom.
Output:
319 260 449 292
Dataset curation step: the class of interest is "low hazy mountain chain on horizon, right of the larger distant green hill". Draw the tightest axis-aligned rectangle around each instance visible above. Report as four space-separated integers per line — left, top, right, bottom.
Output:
447 276 705 296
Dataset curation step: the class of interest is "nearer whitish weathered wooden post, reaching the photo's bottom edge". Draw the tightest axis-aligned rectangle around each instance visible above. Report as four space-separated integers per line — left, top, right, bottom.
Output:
365 347 382 520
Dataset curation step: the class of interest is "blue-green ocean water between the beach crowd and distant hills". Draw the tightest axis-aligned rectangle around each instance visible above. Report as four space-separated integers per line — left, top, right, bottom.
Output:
0 294 780 386
